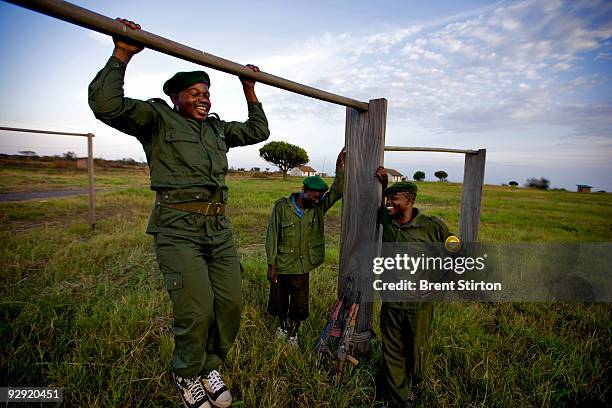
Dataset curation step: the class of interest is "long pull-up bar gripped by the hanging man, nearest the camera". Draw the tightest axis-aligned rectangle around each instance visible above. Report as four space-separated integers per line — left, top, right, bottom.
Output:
5 0 369 111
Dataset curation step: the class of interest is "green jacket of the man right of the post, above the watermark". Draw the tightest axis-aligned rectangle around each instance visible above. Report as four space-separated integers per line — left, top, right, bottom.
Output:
378 206 452 243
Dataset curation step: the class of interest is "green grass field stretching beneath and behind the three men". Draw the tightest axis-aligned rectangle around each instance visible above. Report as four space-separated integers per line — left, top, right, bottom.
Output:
0 164 612 408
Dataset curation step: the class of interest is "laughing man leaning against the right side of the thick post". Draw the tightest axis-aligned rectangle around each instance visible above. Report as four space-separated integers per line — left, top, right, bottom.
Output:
376 167 452 407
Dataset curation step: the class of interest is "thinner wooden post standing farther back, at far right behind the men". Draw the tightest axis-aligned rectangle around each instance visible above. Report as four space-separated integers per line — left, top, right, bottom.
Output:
459 149 487 242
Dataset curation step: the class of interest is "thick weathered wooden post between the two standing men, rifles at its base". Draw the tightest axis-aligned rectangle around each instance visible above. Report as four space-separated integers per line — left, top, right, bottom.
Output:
338 99 387 353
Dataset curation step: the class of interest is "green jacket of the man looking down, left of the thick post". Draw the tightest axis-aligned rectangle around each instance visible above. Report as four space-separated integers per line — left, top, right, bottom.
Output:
266 171 344 274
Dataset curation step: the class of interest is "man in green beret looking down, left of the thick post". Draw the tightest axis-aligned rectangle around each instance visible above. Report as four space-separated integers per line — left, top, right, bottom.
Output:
266 150 346 347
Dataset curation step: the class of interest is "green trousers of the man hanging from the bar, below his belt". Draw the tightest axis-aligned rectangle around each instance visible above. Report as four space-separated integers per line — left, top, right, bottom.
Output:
154 214 242 377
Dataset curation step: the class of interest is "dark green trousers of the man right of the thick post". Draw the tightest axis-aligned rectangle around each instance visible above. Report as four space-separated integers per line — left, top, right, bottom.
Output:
380 302 433 404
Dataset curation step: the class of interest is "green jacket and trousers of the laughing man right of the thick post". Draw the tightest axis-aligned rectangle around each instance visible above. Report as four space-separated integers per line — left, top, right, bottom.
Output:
378 202 452 404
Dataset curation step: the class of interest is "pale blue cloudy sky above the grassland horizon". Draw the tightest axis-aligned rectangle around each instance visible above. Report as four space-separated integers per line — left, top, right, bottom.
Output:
0 0 612 191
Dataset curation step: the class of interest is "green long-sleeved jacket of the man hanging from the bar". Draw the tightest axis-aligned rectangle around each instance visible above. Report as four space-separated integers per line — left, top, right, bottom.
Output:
89 57 270 207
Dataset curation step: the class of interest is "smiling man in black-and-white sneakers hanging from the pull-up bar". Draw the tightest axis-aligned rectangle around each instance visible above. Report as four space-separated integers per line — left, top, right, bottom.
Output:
89 19 269 407
